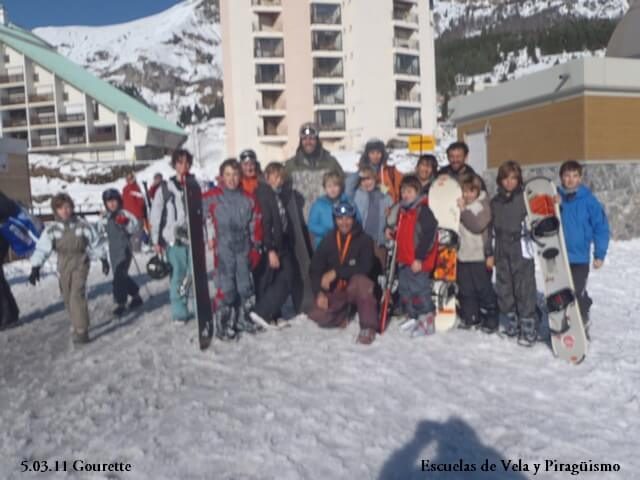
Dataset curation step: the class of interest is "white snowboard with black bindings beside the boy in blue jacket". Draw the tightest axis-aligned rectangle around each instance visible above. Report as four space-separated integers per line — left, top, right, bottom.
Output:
524 177 588 363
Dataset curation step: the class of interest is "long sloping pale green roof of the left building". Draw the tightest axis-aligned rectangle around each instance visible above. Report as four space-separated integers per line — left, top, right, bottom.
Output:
0 24 186 137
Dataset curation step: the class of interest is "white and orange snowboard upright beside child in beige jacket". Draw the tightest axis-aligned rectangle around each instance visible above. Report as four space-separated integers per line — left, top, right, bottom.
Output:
429 175 462 333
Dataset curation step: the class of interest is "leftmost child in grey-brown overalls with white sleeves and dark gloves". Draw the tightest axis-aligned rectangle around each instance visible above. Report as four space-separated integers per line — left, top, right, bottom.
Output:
29 193 109 343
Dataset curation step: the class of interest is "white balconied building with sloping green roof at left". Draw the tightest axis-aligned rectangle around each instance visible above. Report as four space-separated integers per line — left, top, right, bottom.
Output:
0 6 186 161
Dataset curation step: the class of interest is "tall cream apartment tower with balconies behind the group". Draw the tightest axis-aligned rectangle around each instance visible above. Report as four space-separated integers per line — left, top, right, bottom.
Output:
220 0 436 161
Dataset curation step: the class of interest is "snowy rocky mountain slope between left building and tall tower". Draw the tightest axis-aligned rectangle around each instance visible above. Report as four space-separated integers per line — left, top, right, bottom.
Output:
35 0 222 120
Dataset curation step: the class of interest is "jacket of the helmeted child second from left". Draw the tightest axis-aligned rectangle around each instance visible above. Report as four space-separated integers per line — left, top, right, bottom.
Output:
98 209 140 270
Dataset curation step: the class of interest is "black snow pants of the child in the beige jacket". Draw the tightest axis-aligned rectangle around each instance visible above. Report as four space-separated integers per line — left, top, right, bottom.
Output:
457 262 498 325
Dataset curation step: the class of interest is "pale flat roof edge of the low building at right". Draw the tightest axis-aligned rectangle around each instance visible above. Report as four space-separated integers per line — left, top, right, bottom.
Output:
449 57 640 124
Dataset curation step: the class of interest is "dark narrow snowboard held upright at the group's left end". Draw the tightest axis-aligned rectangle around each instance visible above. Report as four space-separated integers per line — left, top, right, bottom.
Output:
184 175 213 350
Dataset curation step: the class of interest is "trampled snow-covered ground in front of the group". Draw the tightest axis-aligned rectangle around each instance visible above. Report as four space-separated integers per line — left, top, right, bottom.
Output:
0 240 640 480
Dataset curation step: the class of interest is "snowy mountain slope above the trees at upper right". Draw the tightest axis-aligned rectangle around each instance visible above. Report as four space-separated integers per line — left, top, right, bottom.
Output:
434 0 629 36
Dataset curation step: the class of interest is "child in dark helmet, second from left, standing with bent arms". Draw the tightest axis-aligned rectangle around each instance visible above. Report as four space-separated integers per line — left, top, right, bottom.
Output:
99 188 142 316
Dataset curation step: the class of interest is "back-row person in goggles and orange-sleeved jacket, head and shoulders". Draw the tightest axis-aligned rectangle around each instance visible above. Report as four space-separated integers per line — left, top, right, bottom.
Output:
345 138 402 203
